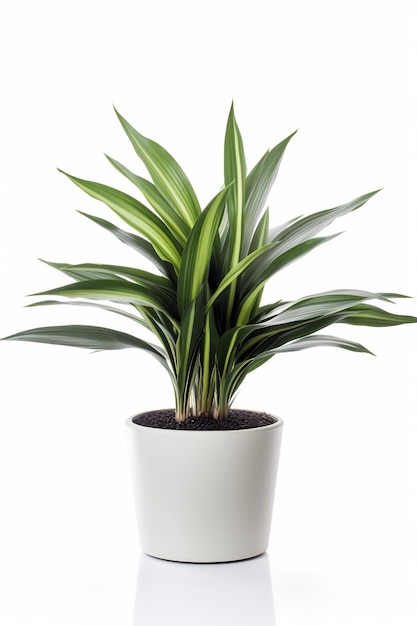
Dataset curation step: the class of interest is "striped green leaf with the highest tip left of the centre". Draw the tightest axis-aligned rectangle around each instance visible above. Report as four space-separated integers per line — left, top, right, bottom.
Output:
116 111 201 228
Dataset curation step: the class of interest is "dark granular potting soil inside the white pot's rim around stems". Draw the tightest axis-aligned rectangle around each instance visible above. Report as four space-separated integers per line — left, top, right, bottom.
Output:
133 409 277 430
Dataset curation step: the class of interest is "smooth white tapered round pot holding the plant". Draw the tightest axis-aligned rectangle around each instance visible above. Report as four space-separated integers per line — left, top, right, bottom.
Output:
127 410 283 563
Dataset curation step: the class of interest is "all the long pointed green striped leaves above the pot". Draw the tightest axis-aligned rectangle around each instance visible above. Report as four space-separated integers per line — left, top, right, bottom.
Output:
6 105 417 421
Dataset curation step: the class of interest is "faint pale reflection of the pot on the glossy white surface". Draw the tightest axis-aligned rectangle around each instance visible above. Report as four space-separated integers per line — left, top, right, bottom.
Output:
133 554 276 626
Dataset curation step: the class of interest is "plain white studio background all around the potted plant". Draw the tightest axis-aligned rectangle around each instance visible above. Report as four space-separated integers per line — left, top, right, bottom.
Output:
0 0 417 626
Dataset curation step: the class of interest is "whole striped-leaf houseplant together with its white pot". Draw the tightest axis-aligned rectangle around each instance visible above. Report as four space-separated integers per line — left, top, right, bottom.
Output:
6 105 417 562
